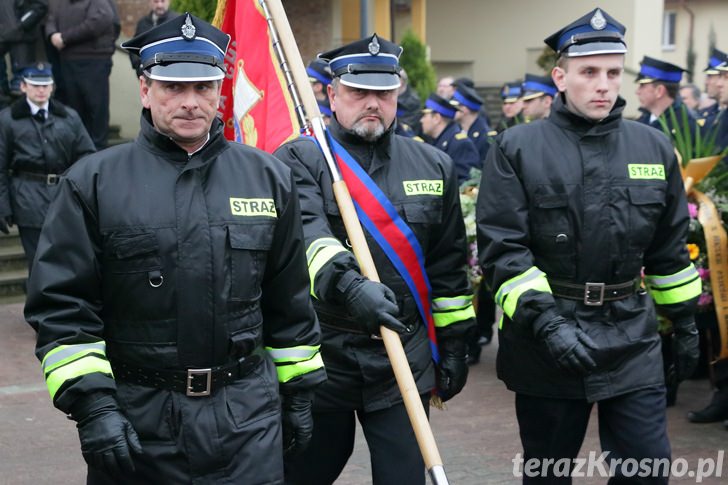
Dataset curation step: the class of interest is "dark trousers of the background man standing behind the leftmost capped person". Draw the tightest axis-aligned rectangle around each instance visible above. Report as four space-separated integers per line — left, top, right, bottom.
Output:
61 58 111 150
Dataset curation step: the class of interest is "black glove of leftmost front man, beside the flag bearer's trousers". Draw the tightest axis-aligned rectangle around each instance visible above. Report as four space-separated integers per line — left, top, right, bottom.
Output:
281 391 313 455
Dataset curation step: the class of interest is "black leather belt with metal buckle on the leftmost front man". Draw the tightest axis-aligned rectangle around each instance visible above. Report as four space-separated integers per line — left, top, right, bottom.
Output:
111 347 265 397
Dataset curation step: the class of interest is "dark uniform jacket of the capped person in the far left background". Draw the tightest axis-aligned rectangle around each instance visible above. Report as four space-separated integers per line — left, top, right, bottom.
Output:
0 98 96 228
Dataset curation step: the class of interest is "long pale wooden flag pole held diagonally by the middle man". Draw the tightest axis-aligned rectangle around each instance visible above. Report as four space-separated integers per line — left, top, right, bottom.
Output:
259 0 448 485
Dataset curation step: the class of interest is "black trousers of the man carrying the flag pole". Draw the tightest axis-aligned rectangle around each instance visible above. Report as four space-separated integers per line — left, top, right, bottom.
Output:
285 397 429 485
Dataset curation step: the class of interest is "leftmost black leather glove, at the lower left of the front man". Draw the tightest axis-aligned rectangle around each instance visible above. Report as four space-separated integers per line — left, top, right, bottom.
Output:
71 393 142 477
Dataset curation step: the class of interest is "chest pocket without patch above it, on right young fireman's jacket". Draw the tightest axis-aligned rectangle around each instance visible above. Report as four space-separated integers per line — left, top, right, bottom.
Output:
531 194 576 278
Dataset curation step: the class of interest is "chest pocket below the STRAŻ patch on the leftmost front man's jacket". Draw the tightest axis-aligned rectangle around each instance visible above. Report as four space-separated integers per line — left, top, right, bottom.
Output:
228 223 275 302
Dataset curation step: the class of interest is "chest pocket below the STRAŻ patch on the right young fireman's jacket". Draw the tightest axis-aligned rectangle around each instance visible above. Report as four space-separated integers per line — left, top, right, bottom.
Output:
627 185 665 248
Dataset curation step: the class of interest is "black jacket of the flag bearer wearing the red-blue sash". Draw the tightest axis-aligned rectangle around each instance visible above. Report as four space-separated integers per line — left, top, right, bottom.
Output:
275 117 473 411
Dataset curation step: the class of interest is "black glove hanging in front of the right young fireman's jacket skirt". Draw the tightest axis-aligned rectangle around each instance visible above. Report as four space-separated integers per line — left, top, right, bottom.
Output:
534 316 597 375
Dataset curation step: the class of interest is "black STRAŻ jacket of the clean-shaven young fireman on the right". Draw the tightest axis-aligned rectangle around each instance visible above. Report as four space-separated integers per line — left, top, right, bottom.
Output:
477 96 697 401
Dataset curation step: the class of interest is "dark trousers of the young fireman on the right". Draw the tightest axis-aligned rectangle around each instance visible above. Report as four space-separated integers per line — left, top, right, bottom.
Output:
516 387 670 485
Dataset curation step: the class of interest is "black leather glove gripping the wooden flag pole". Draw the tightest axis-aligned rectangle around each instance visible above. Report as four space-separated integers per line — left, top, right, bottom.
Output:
336 270 409 335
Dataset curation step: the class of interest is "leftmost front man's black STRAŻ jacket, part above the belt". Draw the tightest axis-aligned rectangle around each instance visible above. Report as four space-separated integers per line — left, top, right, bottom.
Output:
25 110 325 412
